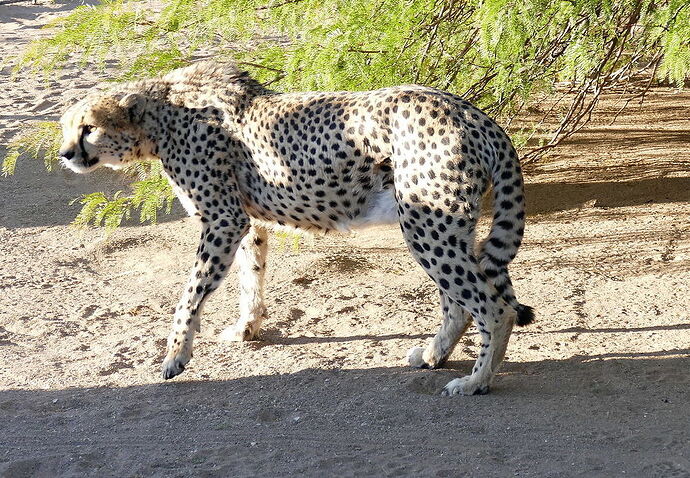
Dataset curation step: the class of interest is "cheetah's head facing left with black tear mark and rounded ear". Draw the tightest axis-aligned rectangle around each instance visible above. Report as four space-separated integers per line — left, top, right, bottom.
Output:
58 93 148 173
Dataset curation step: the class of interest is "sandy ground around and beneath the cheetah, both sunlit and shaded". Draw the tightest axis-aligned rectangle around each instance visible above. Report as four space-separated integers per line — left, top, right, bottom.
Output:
0 3 690 478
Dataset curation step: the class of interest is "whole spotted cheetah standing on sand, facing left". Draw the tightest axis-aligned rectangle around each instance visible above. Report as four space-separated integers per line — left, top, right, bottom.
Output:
59 62 534 395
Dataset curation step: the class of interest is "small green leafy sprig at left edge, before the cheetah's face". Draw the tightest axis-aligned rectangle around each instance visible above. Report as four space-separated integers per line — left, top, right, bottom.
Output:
2 121 62 176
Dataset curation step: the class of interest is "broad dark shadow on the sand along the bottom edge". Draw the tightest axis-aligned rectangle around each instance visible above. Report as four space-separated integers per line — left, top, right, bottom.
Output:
0 349 690 478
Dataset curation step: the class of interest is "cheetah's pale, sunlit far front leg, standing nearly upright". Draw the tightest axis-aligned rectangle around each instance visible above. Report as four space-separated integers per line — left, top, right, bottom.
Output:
220 225 268 342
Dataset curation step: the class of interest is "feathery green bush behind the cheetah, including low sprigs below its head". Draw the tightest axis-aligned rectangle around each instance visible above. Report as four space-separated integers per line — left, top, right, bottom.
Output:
3 0 690 230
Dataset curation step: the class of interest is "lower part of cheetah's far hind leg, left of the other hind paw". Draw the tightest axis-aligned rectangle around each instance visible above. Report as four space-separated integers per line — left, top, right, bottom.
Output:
407 291 472 369
